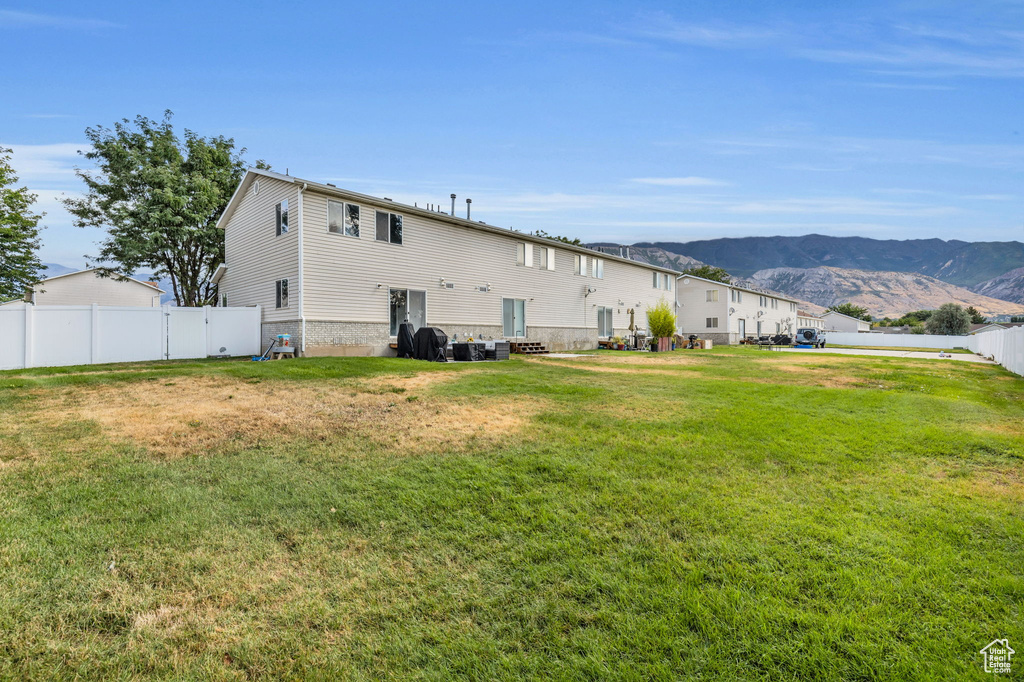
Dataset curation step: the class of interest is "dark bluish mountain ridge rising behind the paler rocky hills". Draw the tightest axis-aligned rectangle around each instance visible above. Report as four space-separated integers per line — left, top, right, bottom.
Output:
631 235 1024 287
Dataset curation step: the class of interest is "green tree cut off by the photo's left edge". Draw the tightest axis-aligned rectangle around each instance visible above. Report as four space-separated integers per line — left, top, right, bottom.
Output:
0 147 45 301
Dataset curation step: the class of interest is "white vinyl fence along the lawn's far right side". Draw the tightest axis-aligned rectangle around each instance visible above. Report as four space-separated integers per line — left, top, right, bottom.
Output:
825 327 1024 376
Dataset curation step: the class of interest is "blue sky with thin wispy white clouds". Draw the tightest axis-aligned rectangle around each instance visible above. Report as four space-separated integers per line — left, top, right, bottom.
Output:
0 0 1024 266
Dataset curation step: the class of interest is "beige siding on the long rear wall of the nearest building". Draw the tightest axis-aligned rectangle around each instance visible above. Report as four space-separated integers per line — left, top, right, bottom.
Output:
303 191 671 333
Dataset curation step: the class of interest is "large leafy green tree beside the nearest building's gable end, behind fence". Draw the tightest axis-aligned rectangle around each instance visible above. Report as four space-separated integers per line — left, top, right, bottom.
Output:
65 111 266 306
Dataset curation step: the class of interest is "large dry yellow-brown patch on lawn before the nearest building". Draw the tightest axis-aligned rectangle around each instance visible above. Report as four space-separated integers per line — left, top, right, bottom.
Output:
37 373 542 456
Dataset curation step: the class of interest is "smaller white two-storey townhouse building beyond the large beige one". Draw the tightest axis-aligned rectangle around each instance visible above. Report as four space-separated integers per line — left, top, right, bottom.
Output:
676 274 797 344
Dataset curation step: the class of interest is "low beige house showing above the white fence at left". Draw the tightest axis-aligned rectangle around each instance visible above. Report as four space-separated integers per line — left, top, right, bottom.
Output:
5 268 164 308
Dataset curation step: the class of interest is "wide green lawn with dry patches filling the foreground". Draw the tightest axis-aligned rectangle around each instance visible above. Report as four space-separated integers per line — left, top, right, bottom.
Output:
0 348 1024 680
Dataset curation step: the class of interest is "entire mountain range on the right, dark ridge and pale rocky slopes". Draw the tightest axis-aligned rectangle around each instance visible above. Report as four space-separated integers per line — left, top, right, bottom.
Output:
588 235 1024 318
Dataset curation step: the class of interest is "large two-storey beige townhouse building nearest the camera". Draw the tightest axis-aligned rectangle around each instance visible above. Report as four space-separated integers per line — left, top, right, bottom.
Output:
214 169 678 355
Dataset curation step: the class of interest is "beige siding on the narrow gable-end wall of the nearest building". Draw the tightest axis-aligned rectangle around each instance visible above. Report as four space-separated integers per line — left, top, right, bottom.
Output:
219 176 299 322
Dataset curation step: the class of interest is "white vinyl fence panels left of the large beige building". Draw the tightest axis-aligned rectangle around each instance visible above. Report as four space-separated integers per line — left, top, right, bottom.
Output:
0 305 262 370
